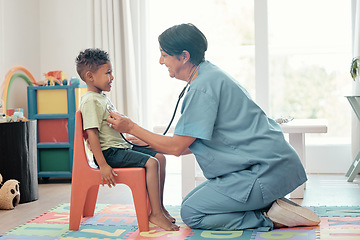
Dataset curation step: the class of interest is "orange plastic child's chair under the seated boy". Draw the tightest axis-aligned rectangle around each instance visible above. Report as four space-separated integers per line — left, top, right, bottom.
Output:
69 111 150 232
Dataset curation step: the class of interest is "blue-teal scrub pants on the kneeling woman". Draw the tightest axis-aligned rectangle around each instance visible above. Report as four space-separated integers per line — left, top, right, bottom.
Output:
181 181 273 231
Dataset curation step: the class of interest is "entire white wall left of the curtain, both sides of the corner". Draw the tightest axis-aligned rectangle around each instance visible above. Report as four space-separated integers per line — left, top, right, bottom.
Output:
0 0 93 116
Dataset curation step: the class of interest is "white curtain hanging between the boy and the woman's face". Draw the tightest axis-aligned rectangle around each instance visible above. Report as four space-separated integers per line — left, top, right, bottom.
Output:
92 0 147 125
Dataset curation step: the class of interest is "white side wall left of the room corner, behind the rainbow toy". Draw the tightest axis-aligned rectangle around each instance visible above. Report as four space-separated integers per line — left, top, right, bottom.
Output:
0 0 40 116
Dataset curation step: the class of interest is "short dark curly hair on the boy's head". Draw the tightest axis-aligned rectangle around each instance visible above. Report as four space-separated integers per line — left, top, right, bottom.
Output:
76 48 110 81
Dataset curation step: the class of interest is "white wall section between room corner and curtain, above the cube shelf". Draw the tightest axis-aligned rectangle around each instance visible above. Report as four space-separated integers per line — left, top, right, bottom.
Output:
39 0 93 79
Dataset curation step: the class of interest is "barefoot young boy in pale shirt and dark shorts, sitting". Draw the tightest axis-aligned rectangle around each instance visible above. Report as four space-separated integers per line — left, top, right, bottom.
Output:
76 49 179 231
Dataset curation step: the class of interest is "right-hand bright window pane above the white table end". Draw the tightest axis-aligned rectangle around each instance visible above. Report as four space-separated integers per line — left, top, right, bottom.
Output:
268 0 352 141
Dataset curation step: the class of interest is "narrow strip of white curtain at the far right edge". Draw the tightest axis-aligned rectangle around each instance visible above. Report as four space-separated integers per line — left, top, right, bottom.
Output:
351 0 360 158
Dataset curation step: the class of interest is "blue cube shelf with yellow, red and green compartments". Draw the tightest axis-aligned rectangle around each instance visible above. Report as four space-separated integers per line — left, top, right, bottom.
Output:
27 84 86 178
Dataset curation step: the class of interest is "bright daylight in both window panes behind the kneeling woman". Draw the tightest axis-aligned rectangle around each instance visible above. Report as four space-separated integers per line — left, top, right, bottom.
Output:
147 0 351 142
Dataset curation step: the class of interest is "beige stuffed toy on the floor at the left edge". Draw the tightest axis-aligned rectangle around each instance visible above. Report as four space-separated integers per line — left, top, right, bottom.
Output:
0 174 20 210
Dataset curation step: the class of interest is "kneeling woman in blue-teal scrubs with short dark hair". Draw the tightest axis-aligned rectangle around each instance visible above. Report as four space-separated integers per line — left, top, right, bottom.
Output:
107 24 320 231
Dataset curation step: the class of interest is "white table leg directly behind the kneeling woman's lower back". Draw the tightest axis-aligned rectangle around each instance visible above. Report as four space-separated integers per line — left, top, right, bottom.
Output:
289 133 306 198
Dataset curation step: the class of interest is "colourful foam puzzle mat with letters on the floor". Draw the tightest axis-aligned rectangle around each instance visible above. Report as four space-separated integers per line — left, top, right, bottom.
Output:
0 203 360 240
